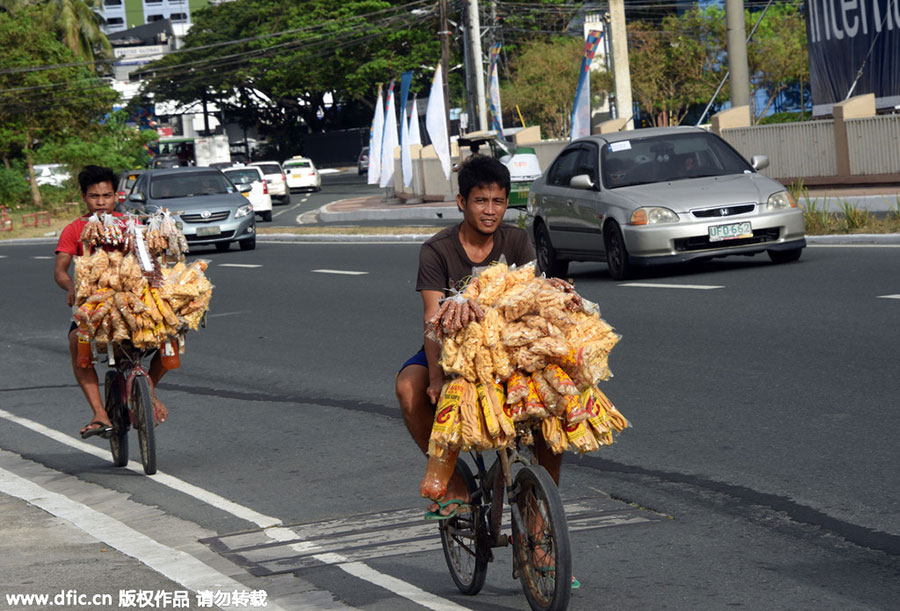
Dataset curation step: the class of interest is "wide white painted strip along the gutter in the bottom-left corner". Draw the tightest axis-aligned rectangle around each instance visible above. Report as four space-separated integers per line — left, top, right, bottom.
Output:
0 469 281 609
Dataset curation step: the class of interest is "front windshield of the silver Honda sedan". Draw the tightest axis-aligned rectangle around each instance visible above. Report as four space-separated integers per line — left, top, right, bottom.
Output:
600 132 753 189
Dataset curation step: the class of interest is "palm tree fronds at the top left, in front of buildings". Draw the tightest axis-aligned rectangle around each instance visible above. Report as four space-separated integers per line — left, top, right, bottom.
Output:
0 0 112 70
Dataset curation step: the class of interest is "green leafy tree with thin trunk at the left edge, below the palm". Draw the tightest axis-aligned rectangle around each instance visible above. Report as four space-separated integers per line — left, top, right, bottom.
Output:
0 7 117 208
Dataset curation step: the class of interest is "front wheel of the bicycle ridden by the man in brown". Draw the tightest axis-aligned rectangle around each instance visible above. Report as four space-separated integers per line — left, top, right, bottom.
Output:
512 465 572 611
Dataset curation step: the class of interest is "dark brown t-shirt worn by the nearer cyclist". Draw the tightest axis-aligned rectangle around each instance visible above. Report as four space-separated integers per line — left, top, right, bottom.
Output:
416 224 534 293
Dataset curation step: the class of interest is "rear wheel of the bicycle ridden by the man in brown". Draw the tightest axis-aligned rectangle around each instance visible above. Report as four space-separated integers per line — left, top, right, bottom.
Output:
440 457 490 595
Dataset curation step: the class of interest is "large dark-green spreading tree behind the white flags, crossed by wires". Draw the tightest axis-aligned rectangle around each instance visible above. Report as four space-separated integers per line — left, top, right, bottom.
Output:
145 0 440 160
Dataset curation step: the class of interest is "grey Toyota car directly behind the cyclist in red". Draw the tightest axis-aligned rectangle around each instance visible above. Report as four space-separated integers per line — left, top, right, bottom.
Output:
124 167 256 252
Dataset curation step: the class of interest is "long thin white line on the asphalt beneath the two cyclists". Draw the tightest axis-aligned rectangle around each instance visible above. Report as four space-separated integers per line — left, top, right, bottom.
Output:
0 409 466 611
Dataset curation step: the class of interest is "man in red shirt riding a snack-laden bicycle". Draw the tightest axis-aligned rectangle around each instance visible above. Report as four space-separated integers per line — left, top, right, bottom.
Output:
53 165 168 438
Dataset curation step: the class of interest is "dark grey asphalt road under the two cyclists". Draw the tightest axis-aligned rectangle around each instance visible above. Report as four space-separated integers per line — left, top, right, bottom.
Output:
0 237 900 610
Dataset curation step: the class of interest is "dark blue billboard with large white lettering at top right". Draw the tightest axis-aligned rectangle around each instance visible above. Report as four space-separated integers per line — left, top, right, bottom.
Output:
806 0 900 115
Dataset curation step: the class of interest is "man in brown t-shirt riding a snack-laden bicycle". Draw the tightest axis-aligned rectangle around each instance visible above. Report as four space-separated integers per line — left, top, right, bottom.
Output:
397 156 561 515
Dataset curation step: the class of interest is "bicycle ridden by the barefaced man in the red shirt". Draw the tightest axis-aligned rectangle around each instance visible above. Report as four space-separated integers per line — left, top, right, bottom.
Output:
103 342 156 475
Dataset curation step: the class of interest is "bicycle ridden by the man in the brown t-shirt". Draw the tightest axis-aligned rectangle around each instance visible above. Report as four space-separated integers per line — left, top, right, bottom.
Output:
440 444 572 611
